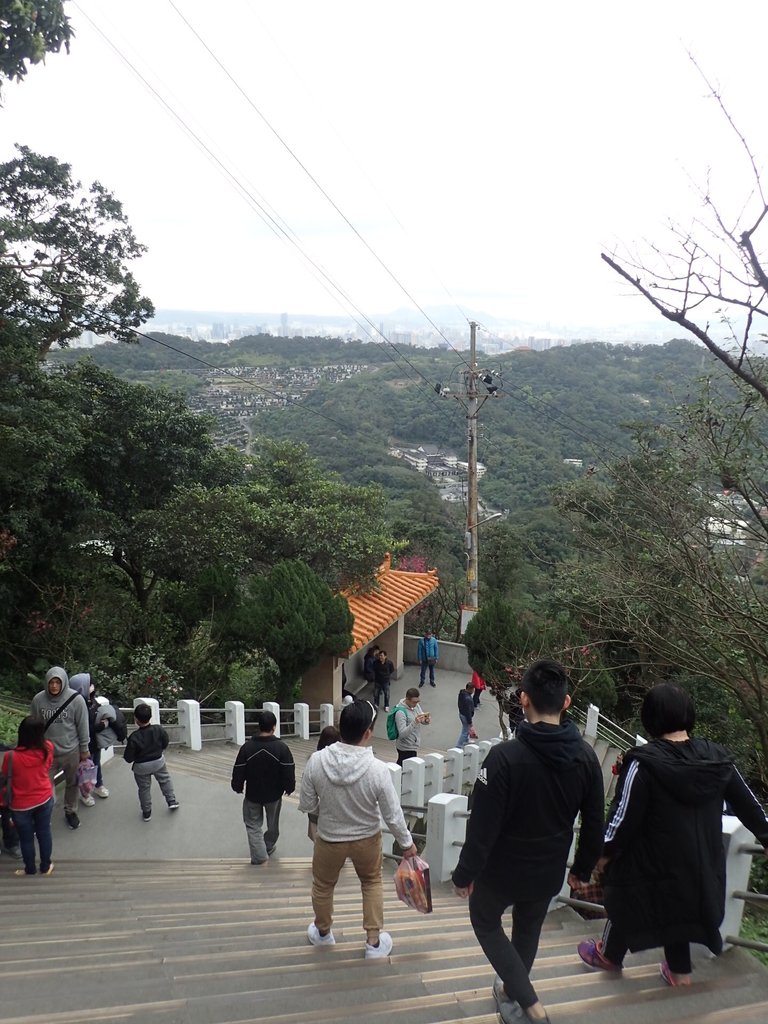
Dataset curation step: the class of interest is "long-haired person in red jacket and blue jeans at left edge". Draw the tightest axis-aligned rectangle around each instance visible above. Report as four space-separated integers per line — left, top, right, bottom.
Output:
2 716 53 876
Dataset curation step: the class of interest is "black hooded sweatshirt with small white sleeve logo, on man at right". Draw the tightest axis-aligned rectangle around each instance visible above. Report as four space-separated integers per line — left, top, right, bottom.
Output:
453 722 604 903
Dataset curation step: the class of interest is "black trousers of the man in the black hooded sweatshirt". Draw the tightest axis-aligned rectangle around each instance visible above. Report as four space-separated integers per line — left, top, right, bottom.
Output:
469 880 551 1010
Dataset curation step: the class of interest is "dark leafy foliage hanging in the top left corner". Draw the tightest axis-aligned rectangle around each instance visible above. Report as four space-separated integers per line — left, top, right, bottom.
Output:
0 0 74 96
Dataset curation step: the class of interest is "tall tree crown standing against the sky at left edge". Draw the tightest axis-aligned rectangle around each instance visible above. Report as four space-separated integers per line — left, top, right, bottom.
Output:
0 145 154 357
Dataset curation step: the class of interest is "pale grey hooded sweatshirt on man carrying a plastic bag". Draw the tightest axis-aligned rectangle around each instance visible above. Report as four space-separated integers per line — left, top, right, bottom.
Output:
299 742 413 850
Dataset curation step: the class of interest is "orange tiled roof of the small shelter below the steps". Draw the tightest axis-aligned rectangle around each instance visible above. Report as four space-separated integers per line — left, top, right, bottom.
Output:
344 555 439 654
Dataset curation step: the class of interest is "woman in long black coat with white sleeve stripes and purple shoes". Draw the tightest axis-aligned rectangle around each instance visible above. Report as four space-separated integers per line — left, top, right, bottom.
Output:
579 683 768 985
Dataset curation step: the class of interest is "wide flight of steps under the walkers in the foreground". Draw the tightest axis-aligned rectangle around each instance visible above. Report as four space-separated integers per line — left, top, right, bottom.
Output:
0 856 768 1024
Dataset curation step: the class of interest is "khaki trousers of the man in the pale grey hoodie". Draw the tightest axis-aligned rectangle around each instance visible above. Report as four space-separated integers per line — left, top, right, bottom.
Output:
312 833 384 945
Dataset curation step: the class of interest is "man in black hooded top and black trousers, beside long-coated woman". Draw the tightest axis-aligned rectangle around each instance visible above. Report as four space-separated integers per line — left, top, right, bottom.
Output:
453 660 604 1022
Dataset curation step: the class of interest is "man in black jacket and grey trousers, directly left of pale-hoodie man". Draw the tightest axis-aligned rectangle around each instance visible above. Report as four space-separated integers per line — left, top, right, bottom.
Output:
231 711 296 864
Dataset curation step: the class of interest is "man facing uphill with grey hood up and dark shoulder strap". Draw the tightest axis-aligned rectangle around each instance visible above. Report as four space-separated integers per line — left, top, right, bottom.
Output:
31 666 90 828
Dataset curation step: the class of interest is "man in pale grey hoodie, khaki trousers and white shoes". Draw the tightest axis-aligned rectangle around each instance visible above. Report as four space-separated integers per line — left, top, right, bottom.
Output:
299 700 417 959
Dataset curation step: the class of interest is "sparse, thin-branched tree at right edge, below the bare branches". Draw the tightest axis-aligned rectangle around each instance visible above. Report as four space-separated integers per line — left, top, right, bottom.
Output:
559 376 768 782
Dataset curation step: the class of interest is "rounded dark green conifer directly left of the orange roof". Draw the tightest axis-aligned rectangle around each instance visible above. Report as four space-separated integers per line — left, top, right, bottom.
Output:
236 561 353 700
